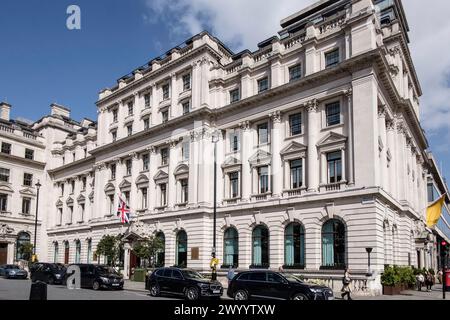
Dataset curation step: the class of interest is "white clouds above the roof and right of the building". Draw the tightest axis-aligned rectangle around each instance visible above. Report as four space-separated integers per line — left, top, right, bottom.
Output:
145 0 450 150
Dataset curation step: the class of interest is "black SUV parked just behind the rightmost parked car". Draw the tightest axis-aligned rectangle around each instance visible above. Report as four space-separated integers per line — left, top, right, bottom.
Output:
147 268 223 300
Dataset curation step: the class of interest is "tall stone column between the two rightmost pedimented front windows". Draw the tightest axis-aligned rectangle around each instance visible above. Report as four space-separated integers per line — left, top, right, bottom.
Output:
306 99 320 192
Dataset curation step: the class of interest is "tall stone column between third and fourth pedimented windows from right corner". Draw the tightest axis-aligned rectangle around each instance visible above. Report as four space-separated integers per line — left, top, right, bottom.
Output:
239 121 253 202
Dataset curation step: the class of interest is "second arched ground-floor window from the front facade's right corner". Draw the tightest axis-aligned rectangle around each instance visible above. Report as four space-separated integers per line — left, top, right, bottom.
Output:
284 223 305 269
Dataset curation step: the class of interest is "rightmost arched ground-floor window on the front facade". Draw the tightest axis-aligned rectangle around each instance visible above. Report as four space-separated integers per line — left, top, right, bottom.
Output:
322 219 346 269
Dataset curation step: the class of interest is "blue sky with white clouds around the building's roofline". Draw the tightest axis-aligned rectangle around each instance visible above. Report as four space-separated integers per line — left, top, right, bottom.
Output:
0 0 450 181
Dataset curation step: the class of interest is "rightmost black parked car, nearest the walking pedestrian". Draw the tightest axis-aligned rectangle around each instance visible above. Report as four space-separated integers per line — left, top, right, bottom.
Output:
227 271 334 300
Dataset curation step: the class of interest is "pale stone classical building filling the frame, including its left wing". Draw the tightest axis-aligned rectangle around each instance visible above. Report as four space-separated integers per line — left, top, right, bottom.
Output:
0 0 450 294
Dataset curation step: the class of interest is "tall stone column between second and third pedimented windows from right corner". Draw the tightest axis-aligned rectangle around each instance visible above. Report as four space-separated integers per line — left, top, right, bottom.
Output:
270 111 283 198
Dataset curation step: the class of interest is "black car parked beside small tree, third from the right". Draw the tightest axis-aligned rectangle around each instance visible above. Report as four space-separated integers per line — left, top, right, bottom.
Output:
65 264 124 290
